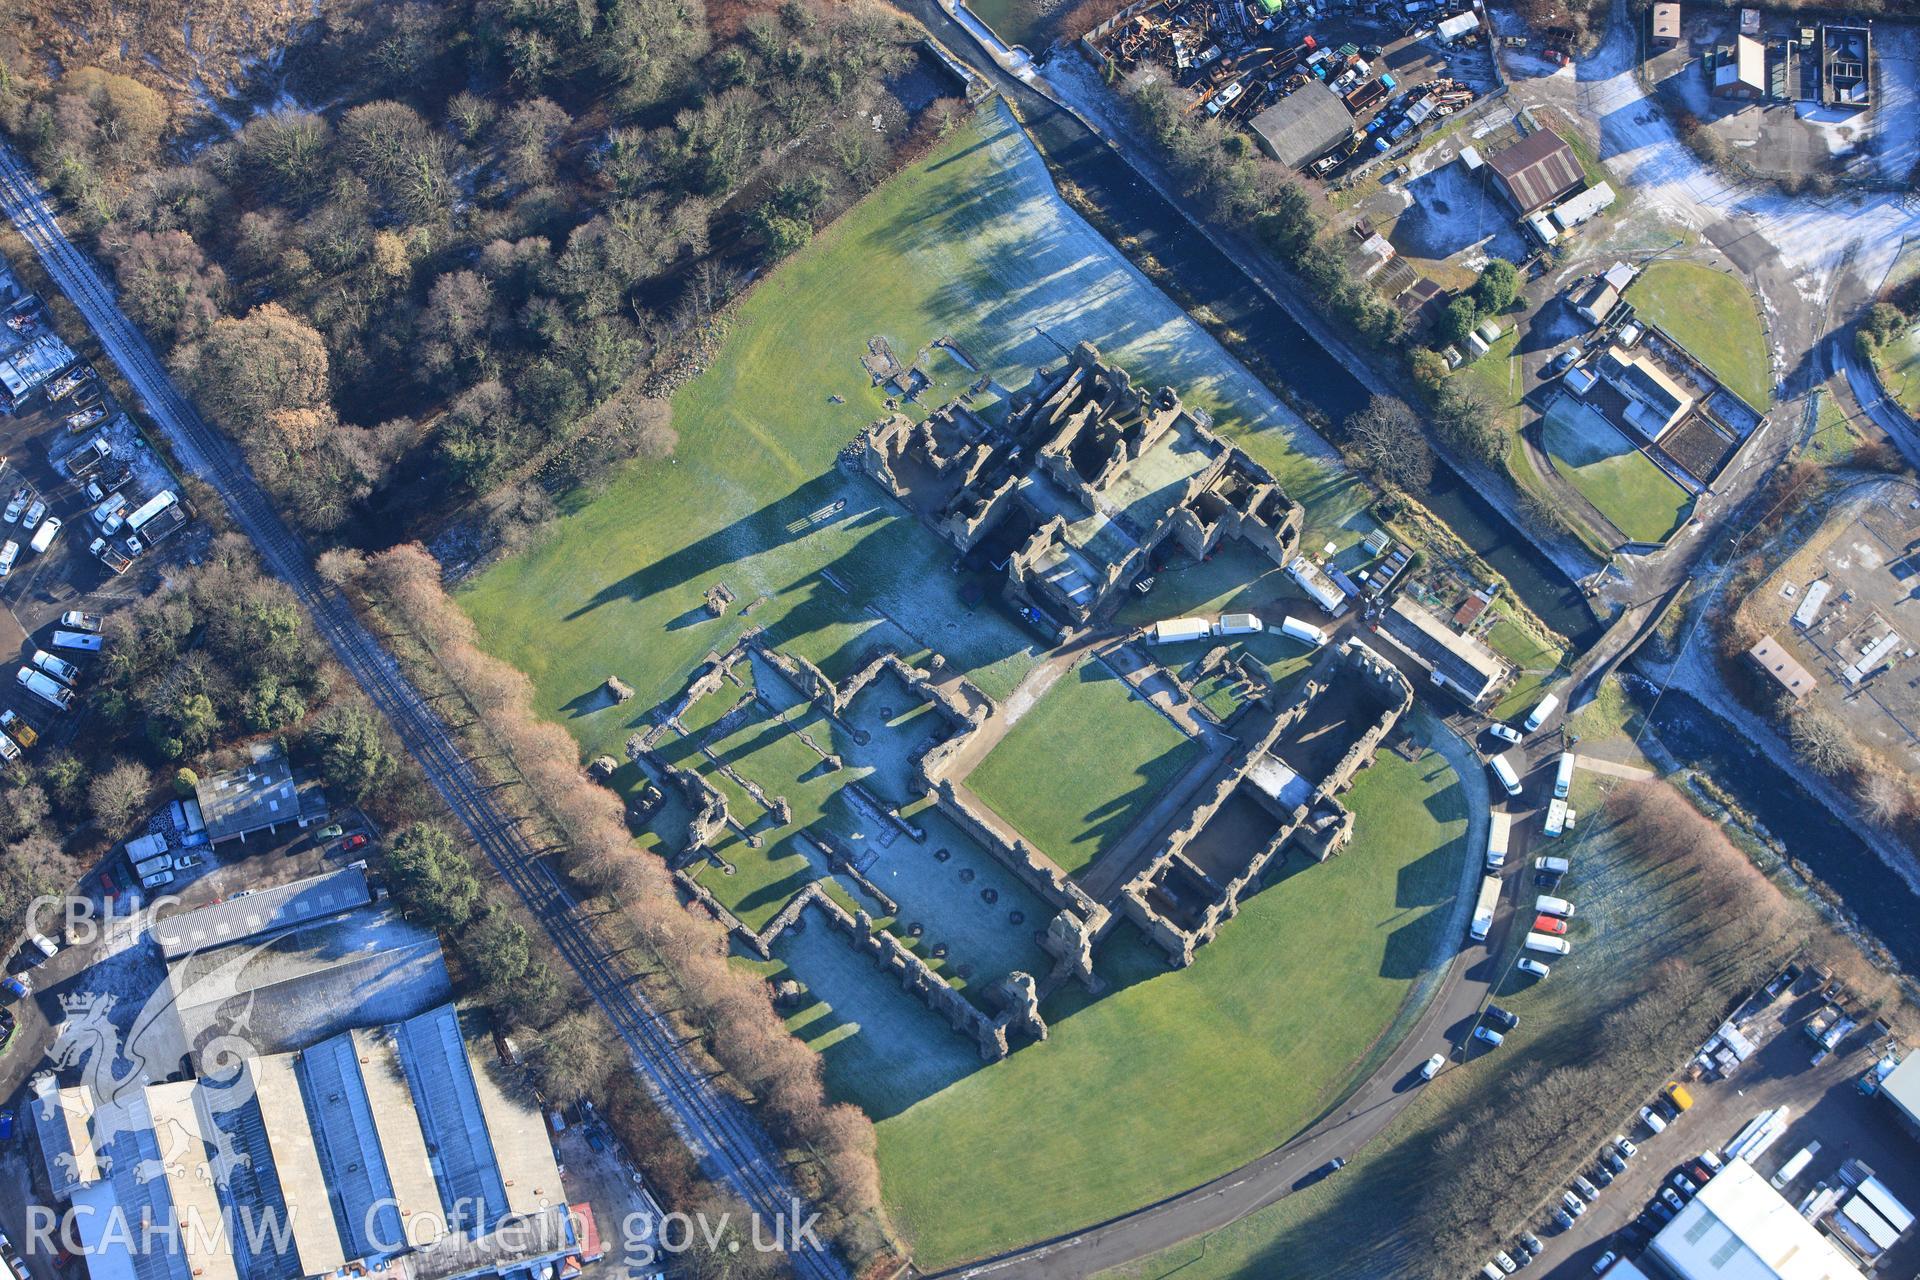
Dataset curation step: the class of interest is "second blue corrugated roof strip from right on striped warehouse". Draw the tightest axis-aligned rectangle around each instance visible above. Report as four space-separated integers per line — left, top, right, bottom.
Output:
296 1034 405 1257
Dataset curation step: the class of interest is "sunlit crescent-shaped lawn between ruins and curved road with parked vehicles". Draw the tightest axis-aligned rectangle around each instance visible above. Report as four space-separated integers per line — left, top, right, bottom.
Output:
883 752 1467 1268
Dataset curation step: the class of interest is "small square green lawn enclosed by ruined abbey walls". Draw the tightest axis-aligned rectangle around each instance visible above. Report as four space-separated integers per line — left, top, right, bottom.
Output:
966 658 1200 875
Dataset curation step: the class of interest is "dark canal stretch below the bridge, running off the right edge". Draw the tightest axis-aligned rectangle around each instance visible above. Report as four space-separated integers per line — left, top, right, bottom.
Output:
1642 691 1920 973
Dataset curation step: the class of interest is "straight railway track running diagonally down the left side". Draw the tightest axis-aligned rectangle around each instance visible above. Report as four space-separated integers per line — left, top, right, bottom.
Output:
0 144 847 1280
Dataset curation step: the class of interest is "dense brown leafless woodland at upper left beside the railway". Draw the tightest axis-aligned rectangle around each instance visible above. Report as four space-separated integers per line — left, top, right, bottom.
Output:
0 0 929 545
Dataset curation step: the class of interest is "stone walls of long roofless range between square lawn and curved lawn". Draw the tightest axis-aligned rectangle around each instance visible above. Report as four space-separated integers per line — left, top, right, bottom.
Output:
1119 639 1413 967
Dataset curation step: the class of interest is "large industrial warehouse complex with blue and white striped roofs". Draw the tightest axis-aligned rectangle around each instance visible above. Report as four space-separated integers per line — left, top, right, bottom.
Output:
27 867 593 1280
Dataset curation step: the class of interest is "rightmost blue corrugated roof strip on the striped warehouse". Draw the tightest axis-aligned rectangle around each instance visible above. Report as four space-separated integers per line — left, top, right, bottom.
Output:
396 1004 507 1232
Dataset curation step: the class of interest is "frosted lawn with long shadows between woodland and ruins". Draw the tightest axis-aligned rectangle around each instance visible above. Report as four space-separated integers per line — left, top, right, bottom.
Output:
459 107 1359 771
